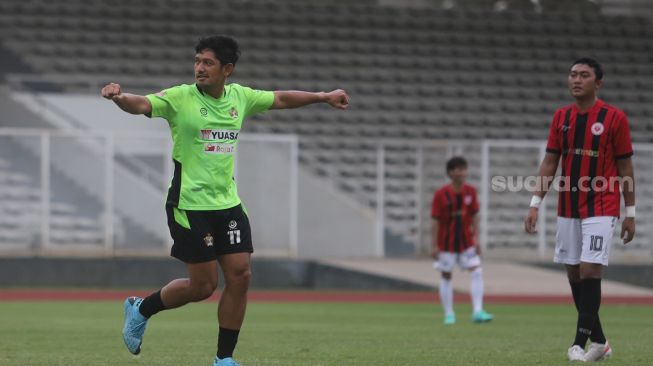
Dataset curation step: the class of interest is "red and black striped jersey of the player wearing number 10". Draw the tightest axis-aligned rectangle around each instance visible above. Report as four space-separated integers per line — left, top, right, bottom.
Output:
546 100 633 219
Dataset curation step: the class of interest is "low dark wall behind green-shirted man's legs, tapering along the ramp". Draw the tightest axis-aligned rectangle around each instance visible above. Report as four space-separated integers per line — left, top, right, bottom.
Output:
0 258 431 291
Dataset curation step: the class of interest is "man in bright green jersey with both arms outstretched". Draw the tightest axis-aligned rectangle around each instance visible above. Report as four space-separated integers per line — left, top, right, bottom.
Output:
102 36 349 366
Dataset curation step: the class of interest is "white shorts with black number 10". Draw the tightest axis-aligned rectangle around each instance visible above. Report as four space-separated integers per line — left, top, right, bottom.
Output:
553 216 617 266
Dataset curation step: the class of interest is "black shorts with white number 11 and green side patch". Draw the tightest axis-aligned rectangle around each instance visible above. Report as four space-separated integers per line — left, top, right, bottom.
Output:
166 205 254 263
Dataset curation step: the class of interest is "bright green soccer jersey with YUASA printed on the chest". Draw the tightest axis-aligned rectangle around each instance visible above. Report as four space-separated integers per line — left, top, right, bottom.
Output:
147 84 274 211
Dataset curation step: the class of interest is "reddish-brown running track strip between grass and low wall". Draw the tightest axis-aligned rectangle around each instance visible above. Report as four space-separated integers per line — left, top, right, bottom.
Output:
0 289 653 305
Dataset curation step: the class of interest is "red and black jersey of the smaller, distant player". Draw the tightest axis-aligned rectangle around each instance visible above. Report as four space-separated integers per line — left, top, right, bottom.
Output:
431 184 478 253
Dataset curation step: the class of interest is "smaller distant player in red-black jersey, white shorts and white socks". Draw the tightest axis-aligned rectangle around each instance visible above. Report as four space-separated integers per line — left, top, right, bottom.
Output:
431 157 493 325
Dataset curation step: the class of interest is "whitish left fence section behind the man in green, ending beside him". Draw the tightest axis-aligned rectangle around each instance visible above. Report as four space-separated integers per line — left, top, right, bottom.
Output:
0 128 298 256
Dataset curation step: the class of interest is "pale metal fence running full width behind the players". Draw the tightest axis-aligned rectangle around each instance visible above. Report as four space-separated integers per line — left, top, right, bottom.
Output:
0 129 653 262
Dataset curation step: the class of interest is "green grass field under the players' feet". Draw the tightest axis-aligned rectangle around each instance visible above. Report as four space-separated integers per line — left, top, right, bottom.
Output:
0 302 653 366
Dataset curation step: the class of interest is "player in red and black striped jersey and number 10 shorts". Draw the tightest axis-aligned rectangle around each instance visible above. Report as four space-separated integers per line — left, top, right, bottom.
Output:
524 58 635 361
